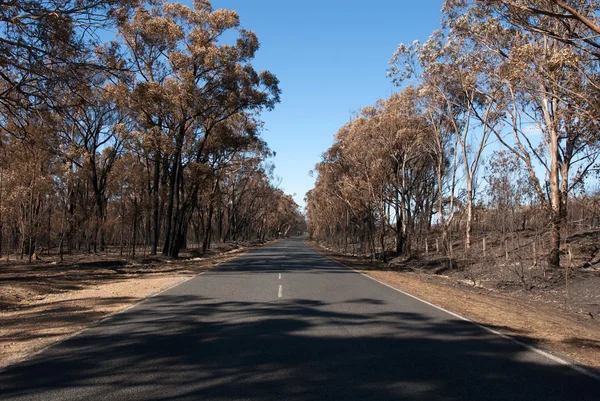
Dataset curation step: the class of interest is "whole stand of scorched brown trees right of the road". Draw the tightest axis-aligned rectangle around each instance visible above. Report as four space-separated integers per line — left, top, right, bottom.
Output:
306 0 600 280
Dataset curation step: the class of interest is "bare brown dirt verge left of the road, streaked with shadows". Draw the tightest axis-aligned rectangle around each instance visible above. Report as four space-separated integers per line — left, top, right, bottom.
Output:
0 244 264 367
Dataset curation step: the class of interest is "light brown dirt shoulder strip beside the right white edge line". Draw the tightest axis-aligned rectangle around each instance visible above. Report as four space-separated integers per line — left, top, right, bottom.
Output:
306 241 600 371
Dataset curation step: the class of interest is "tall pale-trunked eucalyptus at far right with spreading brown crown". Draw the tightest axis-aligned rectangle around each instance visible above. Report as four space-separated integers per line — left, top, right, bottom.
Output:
445 1 599 266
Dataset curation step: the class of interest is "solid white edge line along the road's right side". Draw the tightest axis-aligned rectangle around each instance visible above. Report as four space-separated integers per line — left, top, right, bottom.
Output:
309 242 600 381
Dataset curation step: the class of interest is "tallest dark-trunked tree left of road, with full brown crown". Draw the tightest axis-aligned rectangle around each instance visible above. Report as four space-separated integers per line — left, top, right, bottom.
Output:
120 1 279 256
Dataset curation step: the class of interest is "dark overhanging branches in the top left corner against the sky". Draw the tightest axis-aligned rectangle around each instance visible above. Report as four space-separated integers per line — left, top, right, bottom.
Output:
0 0 135 113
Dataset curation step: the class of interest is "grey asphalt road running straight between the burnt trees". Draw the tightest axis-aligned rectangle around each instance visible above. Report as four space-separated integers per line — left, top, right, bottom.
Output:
0 239 600 401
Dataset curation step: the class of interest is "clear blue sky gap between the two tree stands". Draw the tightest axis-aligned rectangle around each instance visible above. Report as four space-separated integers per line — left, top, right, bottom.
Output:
209 0 442 206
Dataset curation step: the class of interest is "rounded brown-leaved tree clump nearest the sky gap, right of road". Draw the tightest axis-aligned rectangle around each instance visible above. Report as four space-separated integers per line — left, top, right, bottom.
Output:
307 88 435 260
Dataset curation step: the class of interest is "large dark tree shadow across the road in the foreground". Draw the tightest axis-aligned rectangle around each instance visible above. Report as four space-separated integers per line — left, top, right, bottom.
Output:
0 296 599 400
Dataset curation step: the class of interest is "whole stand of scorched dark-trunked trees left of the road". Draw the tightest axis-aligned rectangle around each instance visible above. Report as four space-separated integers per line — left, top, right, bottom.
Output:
0 0 304 262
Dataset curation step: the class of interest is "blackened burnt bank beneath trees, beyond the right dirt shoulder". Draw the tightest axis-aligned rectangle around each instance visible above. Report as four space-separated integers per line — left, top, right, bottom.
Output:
404 230 600 321
